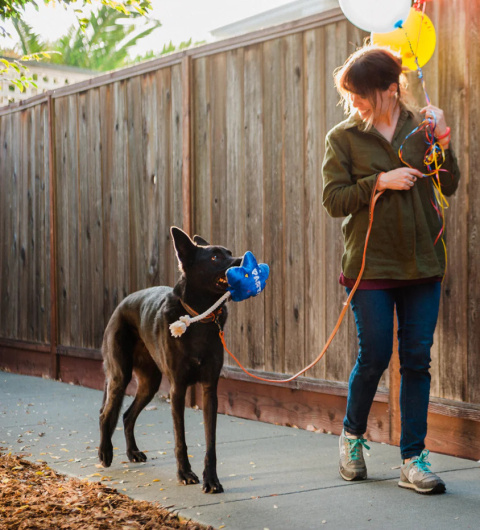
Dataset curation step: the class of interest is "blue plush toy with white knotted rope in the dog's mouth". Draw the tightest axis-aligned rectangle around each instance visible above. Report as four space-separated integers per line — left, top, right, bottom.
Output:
170 251 270 337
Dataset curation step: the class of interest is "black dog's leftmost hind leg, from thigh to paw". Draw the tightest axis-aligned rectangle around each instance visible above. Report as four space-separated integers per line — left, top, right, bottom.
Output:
98 326 133 467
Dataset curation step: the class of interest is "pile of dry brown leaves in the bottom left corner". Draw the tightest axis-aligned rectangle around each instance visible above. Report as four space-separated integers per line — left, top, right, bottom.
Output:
0 453 213 530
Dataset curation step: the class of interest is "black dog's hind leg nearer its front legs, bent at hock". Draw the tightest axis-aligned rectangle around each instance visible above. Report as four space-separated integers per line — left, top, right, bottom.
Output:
123 341 162 462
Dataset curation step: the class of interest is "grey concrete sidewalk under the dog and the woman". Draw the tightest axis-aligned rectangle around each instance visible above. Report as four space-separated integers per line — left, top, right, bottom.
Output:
0 372 480 530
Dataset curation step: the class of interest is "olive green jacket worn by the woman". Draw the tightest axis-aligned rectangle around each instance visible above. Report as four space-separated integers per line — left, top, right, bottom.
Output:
322 107 460 280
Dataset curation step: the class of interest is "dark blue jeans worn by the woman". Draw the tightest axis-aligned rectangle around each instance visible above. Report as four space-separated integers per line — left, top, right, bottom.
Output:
343 282 441 458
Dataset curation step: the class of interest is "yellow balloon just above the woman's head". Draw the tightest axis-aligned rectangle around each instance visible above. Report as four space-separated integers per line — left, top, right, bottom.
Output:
371 7 437 70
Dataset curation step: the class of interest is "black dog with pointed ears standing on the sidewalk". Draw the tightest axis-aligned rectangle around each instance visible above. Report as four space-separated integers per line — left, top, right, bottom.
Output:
98 227 241 493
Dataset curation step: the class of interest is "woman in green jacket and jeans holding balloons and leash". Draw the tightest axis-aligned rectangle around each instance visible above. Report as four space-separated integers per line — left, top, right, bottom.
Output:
322 46 460 493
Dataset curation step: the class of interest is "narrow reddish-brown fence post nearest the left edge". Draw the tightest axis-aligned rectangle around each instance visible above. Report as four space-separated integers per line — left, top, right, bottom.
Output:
48 93 59 379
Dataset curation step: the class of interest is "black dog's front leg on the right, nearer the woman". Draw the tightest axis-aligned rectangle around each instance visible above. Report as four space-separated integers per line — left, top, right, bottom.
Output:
203 384 223 493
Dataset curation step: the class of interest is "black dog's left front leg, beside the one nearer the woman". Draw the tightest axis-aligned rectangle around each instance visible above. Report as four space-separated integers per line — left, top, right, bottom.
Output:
170 385 200 484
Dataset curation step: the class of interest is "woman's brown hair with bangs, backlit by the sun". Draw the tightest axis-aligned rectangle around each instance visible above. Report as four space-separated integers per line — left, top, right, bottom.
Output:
333 44 407 125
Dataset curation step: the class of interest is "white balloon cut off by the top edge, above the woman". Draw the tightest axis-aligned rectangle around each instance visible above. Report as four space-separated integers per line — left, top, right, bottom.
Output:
339 0 411 33
